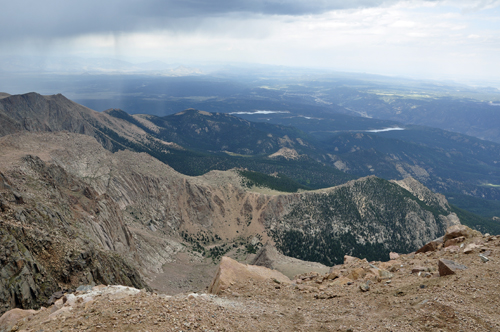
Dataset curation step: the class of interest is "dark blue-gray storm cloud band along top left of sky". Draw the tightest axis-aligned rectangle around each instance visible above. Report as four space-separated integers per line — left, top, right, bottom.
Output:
0 0 398 41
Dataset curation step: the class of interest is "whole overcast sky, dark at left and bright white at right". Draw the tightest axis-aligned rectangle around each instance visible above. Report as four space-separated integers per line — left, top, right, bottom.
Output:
0 0 500 80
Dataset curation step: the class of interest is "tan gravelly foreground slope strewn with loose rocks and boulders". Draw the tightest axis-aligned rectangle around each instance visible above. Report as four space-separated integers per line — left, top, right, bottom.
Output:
0 224 500 332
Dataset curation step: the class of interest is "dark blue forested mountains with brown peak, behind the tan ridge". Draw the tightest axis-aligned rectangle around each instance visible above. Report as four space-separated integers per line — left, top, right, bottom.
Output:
0 93 500 206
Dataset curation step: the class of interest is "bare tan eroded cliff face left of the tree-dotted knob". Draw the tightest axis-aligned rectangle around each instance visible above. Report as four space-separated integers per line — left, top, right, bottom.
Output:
44 137 272 273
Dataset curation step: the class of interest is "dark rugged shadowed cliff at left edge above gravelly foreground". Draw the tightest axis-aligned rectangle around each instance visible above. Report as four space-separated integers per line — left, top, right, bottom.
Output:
0 138 152 312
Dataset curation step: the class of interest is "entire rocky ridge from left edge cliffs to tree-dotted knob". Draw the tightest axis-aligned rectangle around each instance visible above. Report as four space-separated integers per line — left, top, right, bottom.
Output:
0 132 457 316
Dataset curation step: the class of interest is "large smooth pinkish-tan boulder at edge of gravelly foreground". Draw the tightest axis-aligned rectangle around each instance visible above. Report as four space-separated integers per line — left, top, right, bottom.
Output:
208 256 291 294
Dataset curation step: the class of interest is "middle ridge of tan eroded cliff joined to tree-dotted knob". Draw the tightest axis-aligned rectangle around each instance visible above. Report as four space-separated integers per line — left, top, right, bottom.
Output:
24 134 457 264
